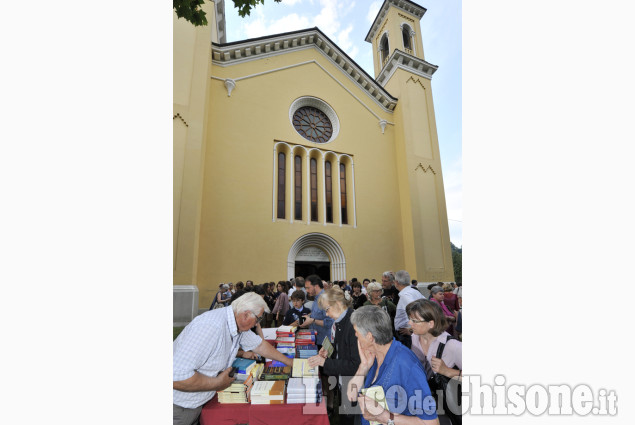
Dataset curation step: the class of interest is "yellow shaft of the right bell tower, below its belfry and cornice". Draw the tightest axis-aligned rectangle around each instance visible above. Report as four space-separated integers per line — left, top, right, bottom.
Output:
386 69 454 281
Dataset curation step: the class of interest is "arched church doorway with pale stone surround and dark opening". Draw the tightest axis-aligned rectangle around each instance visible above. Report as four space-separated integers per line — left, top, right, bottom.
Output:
287 233 346 280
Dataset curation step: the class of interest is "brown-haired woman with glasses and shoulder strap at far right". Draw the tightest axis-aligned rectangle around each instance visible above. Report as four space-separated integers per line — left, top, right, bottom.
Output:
406 299 463 425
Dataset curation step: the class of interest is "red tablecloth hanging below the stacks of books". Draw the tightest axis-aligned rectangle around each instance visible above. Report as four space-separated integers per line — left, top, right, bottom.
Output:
200 395 329 425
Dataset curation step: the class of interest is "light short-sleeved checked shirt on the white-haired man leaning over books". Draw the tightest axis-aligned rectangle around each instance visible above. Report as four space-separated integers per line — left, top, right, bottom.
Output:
172 306 262 409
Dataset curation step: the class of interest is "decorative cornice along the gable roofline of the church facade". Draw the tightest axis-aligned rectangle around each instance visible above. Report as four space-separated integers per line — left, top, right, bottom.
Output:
212 28 397 111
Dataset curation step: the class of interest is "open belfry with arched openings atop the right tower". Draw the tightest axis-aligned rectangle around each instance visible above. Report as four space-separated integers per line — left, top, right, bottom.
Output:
366 0 426 77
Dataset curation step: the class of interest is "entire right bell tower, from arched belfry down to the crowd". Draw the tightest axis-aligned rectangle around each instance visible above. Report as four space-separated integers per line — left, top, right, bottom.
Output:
366 0 454 283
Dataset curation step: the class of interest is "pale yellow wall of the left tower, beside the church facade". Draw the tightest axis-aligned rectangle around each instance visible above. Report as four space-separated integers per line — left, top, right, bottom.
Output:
173 2 216 285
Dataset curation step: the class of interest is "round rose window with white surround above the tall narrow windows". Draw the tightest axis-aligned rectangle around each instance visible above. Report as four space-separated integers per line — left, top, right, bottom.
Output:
289 96 339 143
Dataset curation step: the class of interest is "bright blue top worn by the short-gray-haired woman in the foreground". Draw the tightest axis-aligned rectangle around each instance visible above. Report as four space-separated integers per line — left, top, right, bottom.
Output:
362 338 437 425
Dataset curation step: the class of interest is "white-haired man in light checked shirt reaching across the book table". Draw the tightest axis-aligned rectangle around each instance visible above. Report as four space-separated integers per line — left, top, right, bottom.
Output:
172 292 293 425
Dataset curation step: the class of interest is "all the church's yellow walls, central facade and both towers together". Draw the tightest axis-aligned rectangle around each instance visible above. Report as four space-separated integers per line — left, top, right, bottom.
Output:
174 3 453 308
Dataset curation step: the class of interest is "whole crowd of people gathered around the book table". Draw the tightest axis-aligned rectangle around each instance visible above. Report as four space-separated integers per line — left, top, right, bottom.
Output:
173 270 463 425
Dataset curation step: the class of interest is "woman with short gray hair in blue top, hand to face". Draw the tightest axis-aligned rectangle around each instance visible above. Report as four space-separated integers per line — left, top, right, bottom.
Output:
347 306 439 425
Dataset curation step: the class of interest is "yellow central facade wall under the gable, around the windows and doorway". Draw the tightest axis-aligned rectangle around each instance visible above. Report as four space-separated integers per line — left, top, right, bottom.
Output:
198 48 405 305
